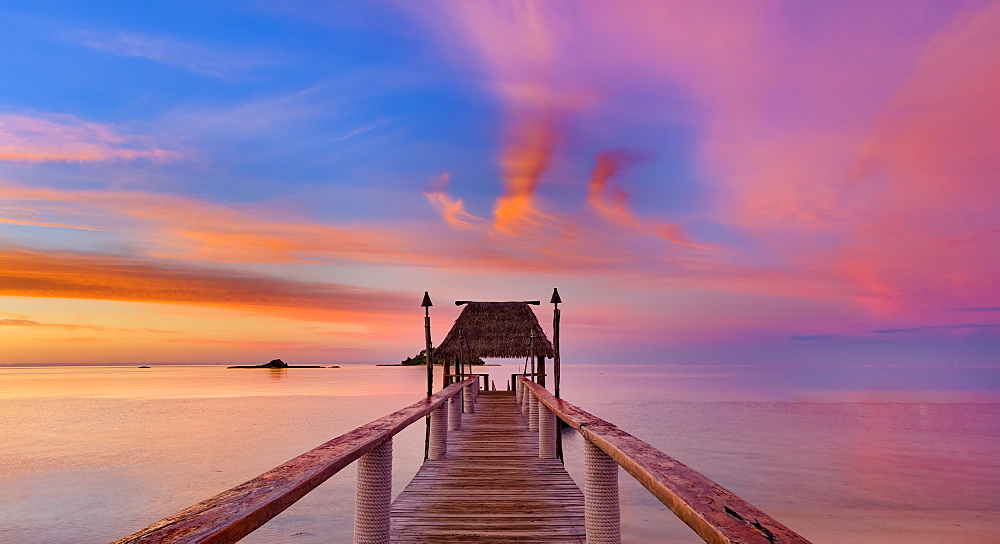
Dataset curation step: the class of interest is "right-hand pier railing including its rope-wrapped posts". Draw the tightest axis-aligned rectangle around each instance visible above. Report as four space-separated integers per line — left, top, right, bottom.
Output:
516 377 809 544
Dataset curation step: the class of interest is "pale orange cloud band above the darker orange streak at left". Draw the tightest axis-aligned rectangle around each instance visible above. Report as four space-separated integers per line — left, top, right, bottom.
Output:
0 182 424 263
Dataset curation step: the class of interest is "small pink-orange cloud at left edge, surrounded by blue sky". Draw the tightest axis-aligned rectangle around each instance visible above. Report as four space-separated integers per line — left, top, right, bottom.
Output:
0 114 180 162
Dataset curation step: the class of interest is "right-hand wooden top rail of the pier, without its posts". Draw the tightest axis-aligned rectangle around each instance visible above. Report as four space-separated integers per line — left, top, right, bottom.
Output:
518 378 809 544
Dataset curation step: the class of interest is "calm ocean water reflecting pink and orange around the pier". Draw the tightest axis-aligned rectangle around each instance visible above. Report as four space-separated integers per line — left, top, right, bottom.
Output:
0 364 1000 544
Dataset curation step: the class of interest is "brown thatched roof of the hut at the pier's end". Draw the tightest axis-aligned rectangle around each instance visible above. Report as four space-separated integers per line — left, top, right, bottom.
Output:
434 302 555 362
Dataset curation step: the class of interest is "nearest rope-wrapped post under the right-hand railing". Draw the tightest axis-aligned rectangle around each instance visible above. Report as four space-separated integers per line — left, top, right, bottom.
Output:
583 439 622 544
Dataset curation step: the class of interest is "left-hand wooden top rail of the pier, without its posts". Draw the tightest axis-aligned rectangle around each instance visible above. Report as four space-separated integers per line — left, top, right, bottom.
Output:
112 378 474 544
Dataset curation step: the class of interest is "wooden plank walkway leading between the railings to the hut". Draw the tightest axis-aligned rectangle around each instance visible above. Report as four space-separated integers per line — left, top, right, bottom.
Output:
392 391 585 544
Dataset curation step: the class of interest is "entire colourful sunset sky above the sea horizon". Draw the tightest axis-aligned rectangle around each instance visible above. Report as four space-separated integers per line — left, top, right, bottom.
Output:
0 0 1000 372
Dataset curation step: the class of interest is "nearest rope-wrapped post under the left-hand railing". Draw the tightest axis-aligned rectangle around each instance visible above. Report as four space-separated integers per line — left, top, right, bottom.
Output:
354 438 392 544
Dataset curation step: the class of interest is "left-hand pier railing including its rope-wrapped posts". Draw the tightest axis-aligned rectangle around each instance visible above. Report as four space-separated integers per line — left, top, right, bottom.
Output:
113 377 479 544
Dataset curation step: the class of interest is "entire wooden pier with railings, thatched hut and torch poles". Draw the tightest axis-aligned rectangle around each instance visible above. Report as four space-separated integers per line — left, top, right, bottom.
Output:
114 298 808 544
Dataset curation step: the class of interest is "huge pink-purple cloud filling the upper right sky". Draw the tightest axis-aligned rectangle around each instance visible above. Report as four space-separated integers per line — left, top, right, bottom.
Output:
424 2 1000 315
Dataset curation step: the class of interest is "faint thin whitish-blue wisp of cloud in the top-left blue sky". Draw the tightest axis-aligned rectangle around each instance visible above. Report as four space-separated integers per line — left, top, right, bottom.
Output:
72 31 275 79
